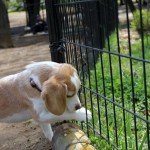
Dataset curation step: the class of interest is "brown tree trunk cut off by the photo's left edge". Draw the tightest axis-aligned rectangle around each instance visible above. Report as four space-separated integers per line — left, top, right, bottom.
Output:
0 0 13 48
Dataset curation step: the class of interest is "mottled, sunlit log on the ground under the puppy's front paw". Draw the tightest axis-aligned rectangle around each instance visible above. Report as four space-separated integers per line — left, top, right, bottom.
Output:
52 123 96 150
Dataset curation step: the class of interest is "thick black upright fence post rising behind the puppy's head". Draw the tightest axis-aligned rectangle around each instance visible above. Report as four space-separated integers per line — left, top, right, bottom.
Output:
45 0 65 63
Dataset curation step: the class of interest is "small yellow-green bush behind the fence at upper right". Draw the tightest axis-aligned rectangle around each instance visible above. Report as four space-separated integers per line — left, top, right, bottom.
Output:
131 9 150 31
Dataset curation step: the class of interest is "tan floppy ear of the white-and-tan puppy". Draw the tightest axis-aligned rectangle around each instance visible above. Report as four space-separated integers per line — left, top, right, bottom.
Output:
41 78 67 115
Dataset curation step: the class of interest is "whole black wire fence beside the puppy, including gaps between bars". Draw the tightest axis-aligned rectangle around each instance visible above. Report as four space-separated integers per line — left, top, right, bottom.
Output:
46 0 150 150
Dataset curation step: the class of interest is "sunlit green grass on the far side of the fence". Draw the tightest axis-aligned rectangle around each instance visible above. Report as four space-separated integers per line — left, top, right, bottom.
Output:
81 29 150 150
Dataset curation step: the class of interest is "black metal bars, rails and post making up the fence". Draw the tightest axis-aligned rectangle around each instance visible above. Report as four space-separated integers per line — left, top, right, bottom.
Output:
45 0 150 149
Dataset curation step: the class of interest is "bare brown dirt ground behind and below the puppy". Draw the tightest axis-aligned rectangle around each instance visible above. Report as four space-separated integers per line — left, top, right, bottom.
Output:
0 13 51 150
